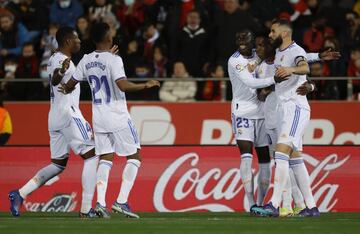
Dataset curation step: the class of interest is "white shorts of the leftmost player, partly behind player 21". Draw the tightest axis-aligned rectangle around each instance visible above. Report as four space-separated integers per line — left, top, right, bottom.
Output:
49 114 95 159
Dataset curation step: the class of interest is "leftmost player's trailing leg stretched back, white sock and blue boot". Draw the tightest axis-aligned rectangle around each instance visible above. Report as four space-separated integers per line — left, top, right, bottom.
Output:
9 154 68 216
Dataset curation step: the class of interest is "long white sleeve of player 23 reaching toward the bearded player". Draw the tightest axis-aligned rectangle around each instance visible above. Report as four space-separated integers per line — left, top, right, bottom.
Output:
229 62 275 89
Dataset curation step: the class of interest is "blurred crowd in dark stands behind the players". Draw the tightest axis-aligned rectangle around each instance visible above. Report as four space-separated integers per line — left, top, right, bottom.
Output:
0 0 360 101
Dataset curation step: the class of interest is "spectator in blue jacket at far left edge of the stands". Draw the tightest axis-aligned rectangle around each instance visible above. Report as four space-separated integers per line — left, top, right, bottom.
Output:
0 13 30 57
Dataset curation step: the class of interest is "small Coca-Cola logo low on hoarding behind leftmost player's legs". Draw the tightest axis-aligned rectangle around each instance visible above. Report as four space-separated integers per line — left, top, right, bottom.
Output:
24 192 77 212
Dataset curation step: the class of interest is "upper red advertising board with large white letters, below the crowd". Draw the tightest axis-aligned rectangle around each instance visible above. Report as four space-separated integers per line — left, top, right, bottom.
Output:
6 102 360 145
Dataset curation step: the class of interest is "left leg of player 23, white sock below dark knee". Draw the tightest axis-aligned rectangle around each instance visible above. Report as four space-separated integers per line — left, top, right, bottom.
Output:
236 140 256 212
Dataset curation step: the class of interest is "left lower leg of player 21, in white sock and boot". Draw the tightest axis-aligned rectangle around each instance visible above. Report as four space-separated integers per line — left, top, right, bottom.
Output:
95 153 114 218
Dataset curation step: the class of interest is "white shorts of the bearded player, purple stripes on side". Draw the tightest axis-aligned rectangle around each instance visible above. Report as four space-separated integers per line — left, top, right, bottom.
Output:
277 101 310 151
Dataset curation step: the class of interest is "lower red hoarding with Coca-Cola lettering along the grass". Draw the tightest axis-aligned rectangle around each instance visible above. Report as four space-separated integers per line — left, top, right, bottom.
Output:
0 146 360 212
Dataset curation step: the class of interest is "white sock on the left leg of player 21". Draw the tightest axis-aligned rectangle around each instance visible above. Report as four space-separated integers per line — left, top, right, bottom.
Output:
96 160 113 207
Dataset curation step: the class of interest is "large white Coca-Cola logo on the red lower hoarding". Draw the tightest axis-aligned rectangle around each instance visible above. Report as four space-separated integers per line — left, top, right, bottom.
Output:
153 152 350 212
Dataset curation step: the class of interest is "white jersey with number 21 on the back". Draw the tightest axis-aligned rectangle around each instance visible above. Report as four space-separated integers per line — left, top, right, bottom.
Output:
73 51 130 132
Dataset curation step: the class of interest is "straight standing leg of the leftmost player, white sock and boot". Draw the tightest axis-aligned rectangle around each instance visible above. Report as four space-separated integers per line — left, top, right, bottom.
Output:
80 149 99 218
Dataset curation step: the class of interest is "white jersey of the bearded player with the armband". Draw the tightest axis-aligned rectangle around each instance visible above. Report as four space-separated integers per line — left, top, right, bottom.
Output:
274 42 310 110
